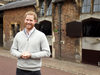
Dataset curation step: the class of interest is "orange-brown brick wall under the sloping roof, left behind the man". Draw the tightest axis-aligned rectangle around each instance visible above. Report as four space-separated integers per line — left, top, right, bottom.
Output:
3 6 35 49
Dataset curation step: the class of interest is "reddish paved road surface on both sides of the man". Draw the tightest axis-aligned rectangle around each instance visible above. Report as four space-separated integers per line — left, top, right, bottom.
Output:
0 56 75 75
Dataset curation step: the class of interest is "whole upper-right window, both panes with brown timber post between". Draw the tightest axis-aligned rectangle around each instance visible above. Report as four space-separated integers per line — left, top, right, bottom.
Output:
81 0 100 13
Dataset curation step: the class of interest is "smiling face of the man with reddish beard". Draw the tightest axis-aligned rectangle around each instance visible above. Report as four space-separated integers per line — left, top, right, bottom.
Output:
24 15 36 30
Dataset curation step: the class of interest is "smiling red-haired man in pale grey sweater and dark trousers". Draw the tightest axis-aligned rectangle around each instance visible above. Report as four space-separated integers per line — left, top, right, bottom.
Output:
11 11 50 75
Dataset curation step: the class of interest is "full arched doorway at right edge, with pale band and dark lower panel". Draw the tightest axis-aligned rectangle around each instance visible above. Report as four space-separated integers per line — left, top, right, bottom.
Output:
82 18 100 65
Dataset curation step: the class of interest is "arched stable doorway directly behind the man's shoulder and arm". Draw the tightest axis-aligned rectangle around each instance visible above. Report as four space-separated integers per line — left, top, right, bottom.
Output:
35 20 52 57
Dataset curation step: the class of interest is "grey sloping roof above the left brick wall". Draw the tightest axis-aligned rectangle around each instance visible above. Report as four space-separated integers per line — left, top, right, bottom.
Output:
0 0 36 11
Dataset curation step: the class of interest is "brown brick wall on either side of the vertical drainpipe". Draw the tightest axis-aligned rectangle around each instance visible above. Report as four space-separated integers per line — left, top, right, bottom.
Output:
54 0 78 61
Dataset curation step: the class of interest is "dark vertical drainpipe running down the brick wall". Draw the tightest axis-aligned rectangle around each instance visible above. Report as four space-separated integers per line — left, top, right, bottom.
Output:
57 3 61 60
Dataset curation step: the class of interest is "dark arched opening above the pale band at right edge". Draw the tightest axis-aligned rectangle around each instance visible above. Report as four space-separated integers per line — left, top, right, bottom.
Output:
82 18 100 37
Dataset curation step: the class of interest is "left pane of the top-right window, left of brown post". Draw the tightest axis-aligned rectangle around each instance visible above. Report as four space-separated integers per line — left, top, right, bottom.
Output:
82 0 91 13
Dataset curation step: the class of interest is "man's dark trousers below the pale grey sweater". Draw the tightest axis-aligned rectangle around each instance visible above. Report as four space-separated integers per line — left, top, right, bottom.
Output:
16 68 41 75
